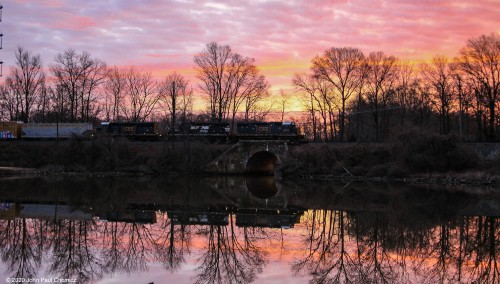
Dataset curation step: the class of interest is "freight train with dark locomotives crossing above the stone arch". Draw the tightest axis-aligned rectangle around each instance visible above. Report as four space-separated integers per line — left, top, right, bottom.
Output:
0 122 306 143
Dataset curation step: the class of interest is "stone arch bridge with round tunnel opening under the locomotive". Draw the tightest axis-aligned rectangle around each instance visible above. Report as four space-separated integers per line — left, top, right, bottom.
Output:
206 140 288 175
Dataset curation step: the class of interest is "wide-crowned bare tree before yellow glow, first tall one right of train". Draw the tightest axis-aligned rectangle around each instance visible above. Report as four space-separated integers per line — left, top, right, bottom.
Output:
312 47 365 141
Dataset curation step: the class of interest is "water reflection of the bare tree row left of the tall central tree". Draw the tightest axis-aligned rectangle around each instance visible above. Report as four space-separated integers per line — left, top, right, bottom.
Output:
0 214 195 283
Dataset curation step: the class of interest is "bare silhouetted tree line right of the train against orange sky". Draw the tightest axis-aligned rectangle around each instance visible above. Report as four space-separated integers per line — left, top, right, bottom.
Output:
292 33 500 141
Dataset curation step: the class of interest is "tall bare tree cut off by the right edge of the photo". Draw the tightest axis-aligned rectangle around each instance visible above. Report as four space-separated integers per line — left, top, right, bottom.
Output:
458 33 500 141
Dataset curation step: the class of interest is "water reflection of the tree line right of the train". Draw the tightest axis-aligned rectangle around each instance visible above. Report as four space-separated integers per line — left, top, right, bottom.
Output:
292 210 500 283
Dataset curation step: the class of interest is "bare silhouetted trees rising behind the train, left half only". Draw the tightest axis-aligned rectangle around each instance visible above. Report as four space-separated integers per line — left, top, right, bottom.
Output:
0 43 269 134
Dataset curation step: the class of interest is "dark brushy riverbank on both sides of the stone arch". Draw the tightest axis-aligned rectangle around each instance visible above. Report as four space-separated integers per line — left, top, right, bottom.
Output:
0 135 500 185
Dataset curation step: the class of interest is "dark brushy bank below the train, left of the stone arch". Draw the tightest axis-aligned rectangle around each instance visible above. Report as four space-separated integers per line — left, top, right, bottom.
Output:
0 139 227 174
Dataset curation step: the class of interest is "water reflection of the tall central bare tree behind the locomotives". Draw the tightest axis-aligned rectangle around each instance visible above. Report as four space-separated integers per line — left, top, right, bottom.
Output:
196 215 265 283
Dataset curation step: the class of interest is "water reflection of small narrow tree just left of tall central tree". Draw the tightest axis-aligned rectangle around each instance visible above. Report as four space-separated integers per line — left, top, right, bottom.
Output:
155 213 191 271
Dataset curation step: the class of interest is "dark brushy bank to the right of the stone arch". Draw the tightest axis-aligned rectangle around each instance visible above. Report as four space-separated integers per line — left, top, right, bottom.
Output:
283 132 500 183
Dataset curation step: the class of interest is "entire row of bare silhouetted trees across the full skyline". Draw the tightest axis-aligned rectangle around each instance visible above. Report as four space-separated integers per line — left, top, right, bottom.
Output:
0 33 500 141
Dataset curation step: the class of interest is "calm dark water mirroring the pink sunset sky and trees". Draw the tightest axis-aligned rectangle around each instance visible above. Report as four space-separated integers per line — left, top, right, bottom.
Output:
0 177 500 284
